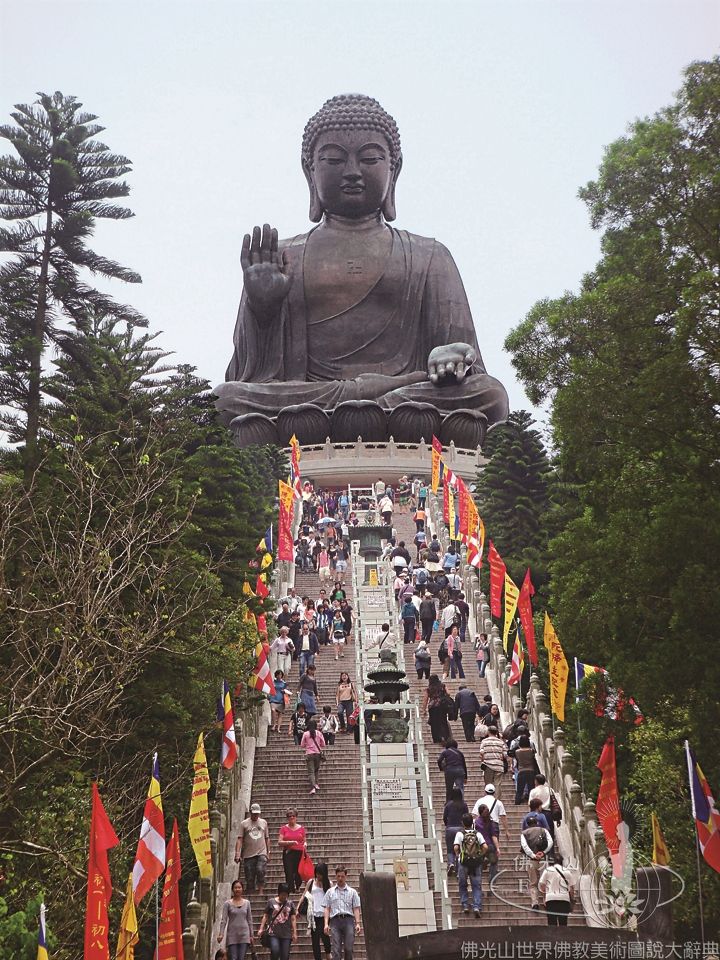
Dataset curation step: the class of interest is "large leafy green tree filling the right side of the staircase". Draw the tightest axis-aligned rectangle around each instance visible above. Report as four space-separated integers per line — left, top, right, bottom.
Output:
506 58 720 936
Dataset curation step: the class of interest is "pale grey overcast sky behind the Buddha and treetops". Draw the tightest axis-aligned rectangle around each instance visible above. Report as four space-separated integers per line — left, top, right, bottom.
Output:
0 0 720 420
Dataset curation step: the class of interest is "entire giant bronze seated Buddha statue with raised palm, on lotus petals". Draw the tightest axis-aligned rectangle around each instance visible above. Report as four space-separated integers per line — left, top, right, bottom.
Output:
215 94 508 448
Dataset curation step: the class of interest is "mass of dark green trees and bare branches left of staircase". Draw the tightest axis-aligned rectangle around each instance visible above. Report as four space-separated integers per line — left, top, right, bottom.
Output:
0 95 286 960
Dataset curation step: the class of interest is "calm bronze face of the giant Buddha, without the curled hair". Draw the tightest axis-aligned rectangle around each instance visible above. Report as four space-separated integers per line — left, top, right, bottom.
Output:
309 130 393 219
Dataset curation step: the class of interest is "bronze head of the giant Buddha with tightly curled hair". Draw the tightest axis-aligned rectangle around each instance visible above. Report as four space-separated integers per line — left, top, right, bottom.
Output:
302 93 402 223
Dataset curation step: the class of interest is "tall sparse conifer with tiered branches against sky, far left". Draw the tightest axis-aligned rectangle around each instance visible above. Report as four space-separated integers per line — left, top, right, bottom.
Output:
0 92 145 476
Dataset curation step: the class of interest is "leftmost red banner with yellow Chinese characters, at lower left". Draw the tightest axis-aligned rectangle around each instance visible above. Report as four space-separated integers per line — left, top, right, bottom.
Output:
84 783 120 960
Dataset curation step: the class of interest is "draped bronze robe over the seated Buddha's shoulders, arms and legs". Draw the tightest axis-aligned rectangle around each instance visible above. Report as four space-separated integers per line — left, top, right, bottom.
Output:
215 228 508 424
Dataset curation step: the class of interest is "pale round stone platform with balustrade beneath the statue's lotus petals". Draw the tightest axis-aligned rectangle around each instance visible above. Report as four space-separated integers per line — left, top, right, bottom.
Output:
286 440 487 488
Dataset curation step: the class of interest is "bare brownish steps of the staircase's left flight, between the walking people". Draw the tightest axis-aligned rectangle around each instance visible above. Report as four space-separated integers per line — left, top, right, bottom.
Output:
228 571 366 960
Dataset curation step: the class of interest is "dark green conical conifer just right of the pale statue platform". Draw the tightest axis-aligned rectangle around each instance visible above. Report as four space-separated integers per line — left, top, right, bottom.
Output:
476 410 552 587
